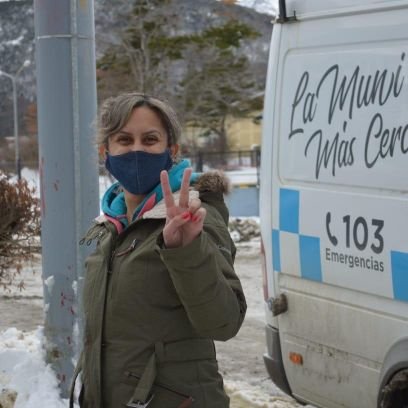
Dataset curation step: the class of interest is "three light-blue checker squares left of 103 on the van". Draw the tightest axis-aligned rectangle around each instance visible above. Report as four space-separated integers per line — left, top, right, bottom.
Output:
272 188 322 282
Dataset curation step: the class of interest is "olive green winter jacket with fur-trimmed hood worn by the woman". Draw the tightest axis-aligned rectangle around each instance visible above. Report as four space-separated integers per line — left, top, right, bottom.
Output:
71 174 246 408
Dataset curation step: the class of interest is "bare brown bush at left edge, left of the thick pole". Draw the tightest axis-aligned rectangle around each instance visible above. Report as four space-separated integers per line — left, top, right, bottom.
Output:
0 172 40 288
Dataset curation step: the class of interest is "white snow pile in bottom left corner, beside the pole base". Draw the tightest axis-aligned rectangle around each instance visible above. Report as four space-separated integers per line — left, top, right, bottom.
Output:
0 328 68 408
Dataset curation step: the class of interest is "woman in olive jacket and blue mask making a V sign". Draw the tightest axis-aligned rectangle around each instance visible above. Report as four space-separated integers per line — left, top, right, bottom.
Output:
71 93 246 408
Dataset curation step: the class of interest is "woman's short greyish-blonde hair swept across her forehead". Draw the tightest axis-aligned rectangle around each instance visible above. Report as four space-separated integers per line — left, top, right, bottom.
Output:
96 92 181 147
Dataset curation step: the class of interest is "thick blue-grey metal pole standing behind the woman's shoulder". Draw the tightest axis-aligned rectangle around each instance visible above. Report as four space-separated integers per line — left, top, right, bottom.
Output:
34 0 99 397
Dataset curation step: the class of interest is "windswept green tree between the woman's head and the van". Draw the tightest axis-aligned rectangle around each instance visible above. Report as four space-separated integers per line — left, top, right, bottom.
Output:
179 20 263 153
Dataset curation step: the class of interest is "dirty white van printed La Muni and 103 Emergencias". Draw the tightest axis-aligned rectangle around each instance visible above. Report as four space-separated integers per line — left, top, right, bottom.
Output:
260 0 408 408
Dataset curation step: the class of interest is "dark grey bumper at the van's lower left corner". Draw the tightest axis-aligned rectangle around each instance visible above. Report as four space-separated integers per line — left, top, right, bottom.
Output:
263 325 292 396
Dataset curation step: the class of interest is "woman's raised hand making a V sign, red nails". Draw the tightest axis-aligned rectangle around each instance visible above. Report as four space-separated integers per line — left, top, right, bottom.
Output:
160 167 206 248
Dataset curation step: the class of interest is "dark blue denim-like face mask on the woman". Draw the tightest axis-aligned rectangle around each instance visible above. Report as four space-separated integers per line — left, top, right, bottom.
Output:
105 149 173 194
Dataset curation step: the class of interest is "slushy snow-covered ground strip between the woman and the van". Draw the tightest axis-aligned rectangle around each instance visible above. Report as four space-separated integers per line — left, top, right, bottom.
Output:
216 244 301 408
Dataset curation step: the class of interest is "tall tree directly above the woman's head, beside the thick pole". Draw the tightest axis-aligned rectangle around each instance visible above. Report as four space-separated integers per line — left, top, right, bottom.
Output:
98 0 188 101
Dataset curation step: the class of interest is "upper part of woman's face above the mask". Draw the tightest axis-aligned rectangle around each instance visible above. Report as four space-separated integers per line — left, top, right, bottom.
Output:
108 106 177 156
